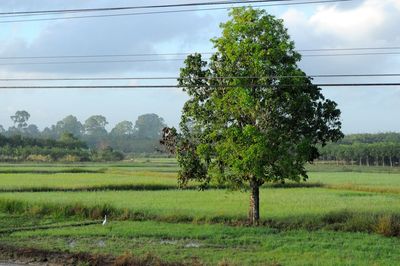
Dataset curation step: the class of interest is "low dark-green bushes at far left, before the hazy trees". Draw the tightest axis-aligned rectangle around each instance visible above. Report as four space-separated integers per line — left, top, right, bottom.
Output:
0 133 124 162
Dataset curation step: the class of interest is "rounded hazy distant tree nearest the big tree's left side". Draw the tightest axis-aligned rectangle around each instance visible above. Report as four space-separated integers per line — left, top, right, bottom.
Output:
134 114 166 139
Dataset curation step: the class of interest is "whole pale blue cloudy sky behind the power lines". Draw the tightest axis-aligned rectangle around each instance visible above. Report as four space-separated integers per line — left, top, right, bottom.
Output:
0 0 400 134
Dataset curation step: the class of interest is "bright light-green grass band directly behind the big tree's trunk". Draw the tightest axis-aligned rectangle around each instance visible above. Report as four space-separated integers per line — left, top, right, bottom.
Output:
0 188 400 228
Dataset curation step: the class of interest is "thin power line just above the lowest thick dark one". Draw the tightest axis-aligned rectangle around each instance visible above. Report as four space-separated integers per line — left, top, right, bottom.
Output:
0 73 400 82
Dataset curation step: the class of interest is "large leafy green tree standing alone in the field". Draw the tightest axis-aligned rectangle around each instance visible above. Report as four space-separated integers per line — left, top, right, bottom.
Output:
162 8 342 224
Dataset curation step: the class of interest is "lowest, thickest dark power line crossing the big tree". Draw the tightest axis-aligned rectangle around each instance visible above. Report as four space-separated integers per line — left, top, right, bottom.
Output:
0 82 400 89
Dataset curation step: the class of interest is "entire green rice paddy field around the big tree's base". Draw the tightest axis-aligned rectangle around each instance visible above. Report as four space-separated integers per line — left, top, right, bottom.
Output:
0 159 400 265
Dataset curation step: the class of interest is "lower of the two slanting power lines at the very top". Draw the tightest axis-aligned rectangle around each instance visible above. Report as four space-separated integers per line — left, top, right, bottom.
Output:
0 0 353 23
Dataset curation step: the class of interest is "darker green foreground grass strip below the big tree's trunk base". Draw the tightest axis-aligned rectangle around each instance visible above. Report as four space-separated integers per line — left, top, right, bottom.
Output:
0 217 400 265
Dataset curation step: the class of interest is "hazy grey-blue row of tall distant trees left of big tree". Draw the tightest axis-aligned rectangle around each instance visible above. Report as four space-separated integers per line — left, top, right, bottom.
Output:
0 111 166 154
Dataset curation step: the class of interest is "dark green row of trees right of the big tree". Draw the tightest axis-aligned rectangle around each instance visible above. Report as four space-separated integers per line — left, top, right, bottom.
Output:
320 133 400 166
